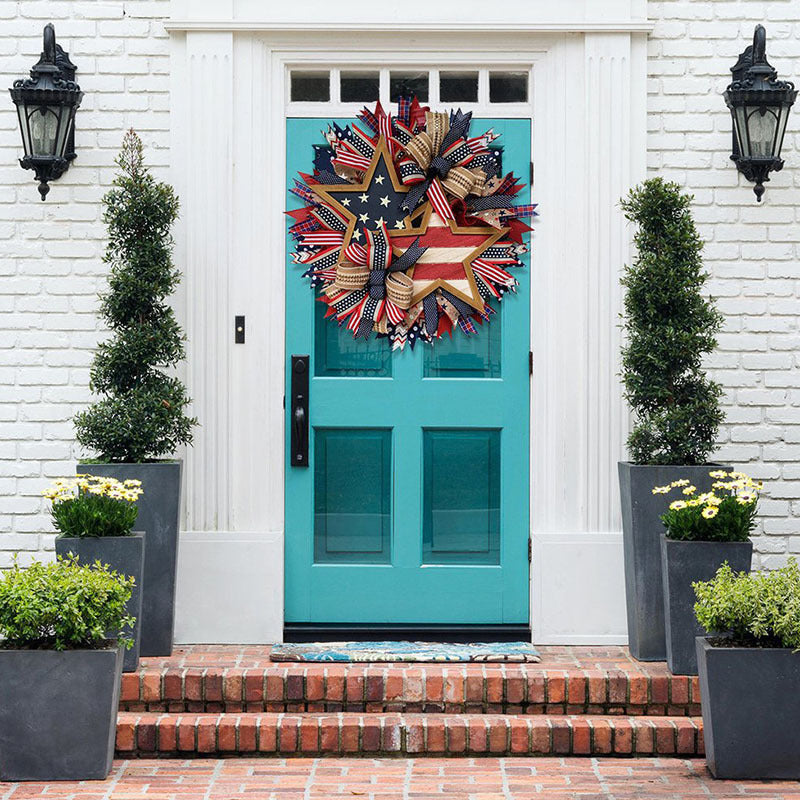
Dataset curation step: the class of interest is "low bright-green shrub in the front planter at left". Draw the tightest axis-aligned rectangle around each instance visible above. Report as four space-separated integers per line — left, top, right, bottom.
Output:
0 557 135 650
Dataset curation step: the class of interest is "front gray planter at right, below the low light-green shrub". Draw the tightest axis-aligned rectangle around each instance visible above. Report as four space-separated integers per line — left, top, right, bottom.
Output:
697 637 800 780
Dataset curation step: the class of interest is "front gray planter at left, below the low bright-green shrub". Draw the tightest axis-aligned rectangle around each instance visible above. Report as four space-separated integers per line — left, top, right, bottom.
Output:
0 645 122 782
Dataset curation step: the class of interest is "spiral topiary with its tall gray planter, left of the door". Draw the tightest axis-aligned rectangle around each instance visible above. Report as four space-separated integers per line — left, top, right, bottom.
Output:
75 131 197 656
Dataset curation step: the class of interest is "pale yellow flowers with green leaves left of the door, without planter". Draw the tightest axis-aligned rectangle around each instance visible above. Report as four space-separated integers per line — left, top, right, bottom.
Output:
42 475 143 538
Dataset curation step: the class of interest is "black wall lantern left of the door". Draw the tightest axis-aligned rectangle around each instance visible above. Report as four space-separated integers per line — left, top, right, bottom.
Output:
9 24 83 200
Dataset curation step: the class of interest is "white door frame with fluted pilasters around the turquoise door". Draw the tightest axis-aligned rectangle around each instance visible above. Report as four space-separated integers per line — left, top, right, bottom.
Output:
168 18 646 642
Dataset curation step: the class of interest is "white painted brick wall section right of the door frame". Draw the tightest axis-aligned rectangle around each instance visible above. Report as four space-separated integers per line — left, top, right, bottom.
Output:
648 0 800 566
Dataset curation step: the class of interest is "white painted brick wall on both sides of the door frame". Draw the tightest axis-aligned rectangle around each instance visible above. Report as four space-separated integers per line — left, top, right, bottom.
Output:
0 0 800 568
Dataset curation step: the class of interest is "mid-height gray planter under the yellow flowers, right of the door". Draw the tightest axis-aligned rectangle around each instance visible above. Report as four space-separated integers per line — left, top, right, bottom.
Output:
661 534 753 675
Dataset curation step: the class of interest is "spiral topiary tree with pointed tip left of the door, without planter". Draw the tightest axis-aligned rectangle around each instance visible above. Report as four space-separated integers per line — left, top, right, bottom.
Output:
75 130 197 462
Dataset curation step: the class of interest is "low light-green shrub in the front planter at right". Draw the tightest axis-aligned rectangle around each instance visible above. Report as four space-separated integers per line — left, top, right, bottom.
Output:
692 558 800 649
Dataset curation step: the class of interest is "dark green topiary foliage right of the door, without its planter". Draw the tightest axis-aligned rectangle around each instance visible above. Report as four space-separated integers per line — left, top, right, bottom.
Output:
622 178 724 465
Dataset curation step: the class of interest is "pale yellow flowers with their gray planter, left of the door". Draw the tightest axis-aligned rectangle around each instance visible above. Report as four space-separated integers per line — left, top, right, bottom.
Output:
43 475 145 672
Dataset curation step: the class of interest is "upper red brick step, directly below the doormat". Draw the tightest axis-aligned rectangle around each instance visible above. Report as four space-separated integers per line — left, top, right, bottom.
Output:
120 664 700 717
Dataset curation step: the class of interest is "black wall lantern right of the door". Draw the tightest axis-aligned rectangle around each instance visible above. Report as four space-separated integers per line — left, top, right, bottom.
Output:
724 25 797 202
